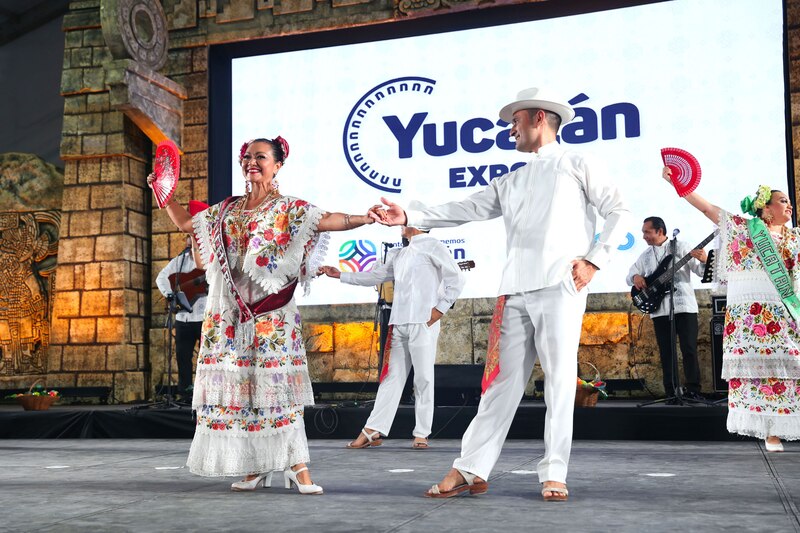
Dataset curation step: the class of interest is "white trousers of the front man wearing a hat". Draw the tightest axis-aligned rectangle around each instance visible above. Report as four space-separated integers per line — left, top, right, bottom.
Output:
453 278 587 483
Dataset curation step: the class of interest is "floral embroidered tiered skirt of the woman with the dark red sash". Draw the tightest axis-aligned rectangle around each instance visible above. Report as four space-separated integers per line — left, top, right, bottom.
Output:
186 304 314 476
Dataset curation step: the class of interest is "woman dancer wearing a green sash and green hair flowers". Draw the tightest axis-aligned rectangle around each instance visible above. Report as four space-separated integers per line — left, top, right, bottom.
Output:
662 168 800 452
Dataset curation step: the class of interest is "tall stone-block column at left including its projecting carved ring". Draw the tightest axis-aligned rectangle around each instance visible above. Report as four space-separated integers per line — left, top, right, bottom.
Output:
49 0 185 402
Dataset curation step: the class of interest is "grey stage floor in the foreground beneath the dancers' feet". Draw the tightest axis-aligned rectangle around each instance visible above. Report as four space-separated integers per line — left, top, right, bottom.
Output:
0 439 800 533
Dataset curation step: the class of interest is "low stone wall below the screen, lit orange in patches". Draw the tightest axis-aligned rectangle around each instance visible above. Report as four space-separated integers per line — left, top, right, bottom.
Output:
301 290 713 396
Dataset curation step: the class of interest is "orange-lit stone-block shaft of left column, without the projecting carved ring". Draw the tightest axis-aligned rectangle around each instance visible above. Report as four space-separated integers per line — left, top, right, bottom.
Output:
47 1 152 401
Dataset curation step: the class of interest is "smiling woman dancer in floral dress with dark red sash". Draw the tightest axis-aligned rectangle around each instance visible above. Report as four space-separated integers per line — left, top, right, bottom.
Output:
148 137 372 494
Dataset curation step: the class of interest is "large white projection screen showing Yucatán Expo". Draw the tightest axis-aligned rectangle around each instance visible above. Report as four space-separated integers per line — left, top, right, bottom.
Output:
210 0 793 305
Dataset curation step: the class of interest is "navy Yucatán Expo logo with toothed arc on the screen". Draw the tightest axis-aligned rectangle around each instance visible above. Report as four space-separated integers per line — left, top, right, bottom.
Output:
342 76 641 193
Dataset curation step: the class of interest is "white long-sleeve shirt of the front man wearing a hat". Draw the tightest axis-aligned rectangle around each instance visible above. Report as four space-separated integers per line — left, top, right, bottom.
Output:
406 141 630 295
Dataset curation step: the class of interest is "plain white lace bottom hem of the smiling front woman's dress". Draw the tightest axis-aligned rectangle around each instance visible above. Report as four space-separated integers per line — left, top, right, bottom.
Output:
186 422 310 477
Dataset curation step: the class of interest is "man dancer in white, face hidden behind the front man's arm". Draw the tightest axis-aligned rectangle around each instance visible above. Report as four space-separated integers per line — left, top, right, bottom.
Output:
320 220 464 449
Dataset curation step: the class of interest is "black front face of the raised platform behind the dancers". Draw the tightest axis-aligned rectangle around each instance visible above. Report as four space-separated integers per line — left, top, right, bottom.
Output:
0 400 740 441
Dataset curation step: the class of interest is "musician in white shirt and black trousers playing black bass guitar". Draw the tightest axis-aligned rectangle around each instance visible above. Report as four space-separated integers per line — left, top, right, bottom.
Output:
626 217 708 399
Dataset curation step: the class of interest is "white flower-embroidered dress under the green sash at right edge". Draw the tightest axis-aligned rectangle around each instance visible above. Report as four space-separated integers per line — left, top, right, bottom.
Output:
716 211 800 440
